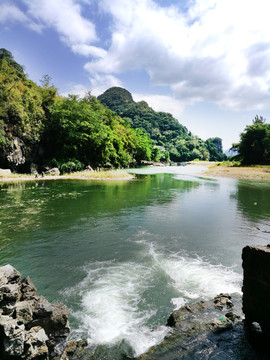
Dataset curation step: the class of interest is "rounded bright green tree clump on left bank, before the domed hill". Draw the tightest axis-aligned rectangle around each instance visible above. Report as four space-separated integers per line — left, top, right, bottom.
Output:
44 95 152 167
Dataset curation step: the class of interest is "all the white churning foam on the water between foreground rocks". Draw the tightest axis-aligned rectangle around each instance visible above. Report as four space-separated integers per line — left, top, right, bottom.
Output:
66 240 241 356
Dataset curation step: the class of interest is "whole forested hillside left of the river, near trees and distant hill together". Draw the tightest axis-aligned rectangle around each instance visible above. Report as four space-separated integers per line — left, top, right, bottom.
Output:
0 49 225 172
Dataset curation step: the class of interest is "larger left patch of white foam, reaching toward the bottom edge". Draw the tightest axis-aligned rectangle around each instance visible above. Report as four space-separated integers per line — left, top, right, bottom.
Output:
70 263 168 356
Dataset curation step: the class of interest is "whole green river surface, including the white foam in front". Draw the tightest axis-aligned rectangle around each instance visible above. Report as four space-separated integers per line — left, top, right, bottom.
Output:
0 166 270 355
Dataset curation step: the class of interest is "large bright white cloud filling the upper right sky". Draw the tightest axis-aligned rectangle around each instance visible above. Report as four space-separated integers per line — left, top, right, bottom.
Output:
85 0 270 110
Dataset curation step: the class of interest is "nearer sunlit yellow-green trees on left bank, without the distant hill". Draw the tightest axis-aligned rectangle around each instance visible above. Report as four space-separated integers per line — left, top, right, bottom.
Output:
0 49 158 171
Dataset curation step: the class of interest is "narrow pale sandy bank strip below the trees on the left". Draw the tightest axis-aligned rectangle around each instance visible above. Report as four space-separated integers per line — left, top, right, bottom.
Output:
0 170 134 182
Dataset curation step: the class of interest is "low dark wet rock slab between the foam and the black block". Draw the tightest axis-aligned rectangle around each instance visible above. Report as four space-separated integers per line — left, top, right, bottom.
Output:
139 294 266 360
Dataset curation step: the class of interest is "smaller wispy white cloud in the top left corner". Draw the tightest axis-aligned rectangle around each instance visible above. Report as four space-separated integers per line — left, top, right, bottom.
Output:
0 0 102 57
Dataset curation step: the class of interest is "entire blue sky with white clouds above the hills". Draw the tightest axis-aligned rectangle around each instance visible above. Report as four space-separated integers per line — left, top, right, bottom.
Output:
0 0 270 150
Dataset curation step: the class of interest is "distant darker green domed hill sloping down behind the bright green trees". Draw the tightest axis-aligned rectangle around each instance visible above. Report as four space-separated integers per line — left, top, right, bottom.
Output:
98 87 226 162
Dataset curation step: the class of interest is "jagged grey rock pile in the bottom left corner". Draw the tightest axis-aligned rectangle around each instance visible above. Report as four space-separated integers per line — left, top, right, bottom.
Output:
0 265 85 360
